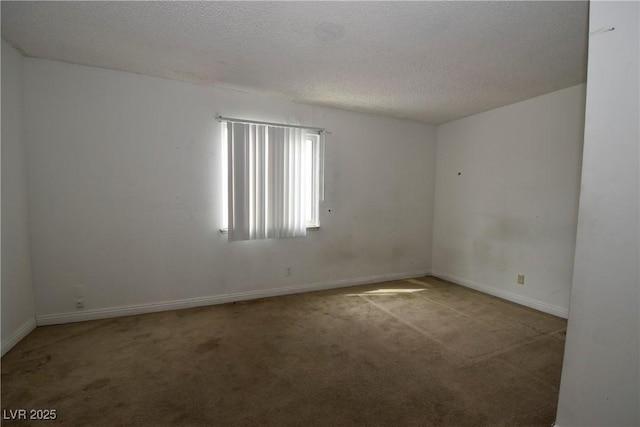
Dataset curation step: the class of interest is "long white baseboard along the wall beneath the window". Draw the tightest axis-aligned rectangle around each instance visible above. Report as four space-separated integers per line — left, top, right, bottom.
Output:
37 271 430 328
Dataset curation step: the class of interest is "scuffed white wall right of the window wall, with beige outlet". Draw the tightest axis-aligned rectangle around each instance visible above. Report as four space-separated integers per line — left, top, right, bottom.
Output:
433 85 585 317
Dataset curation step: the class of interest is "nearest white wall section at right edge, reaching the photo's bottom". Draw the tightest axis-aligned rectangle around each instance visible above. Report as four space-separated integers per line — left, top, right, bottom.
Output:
557 2 640 427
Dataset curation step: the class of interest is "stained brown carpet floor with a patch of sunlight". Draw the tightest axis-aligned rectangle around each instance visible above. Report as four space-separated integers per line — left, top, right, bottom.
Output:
2 277 566 426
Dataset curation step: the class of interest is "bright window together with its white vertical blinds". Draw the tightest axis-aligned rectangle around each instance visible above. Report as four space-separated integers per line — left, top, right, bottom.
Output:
219 118 324 241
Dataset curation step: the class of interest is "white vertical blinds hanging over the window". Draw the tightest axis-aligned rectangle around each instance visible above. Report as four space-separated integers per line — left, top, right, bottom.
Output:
227 122 308 241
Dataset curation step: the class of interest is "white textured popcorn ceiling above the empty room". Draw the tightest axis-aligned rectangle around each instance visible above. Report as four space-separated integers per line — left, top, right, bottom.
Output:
2 1 588 124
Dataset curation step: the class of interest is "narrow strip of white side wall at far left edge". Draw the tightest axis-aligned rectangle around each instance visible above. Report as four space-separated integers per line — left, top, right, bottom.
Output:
2 40 35 354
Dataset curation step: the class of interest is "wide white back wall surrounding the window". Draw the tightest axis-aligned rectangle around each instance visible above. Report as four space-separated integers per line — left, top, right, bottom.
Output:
25 59 435 324
